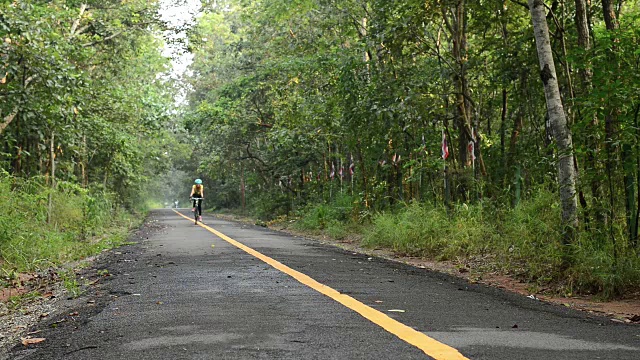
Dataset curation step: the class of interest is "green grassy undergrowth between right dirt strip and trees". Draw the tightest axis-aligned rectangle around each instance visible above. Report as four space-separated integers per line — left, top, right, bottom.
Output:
293 191 640 300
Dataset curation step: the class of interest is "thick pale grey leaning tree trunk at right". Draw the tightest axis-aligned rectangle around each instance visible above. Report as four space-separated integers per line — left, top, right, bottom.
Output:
528 0 578 239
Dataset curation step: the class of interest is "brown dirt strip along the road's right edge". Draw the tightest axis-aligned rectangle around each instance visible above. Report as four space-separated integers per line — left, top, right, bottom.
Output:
216 214 640 324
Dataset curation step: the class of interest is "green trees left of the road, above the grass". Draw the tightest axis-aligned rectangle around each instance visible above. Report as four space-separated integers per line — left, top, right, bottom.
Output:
0 0 180 207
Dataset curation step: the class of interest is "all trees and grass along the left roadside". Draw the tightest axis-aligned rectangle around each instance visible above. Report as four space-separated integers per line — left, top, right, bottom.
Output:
0 0 180 270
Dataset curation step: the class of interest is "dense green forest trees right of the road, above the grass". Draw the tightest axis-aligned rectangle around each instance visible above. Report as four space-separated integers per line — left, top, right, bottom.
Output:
186 0 640 296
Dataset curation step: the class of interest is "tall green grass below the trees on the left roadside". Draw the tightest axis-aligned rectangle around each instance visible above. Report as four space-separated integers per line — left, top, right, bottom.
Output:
0 174 140 272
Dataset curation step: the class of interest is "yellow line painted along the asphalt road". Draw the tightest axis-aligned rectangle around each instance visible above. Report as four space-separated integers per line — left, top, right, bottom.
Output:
174 210 467 360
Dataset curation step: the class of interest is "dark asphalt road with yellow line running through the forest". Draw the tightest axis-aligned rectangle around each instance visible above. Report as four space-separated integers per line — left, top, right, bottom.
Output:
11 210 640 360
